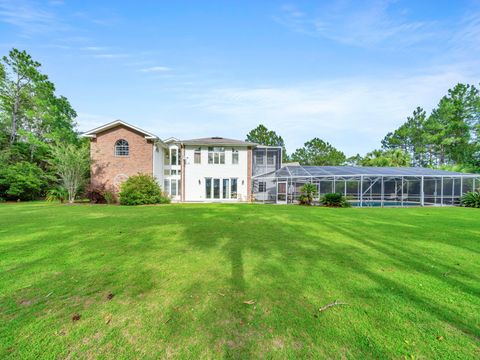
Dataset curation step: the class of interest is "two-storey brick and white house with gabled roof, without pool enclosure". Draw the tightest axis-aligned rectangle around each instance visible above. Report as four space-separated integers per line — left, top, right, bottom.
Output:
82 120 282 202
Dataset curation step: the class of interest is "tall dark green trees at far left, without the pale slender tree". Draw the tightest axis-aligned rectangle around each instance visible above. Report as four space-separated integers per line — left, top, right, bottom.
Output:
0 49 80 199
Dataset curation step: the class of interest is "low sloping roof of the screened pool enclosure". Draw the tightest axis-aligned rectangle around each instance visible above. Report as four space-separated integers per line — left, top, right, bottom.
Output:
258 165 471 177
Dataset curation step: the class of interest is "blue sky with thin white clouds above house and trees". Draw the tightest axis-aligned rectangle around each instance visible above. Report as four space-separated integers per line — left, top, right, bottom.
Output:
0 0 480 155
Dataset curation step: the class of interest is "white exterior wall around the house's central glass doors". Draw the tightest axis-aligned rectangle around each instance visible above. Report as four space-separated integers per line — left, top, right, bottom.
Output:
183 145 251 202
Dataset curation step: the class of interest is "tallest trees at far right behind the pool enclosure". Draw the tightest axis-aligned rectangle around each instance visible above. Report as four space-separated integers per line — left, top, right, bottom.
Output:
382 84 480 168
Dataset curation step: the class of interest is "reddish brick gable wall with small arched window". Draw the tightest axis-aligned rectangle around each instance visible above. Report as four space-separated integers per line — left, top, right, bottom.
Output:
90 125 153 191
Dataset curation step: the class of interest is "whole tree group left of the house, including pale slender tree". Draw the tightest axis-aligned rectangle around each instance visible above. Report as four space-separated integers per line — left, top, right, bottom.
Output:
0 49 89 201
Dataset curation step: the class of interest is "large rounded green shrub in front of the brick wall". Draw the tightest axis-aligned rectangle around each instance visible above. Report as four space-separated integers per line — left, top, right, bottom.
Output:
119 174 170 205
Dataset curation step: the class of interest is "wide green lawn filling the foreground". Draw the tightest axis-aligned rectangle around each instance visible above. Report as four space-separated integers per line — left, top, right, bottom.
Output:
0 203 480 359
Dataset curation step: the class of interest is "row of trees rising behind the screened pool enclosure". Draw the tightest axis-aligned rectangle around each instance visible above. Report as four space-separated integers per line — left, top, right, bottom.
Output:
246 84 480 172
